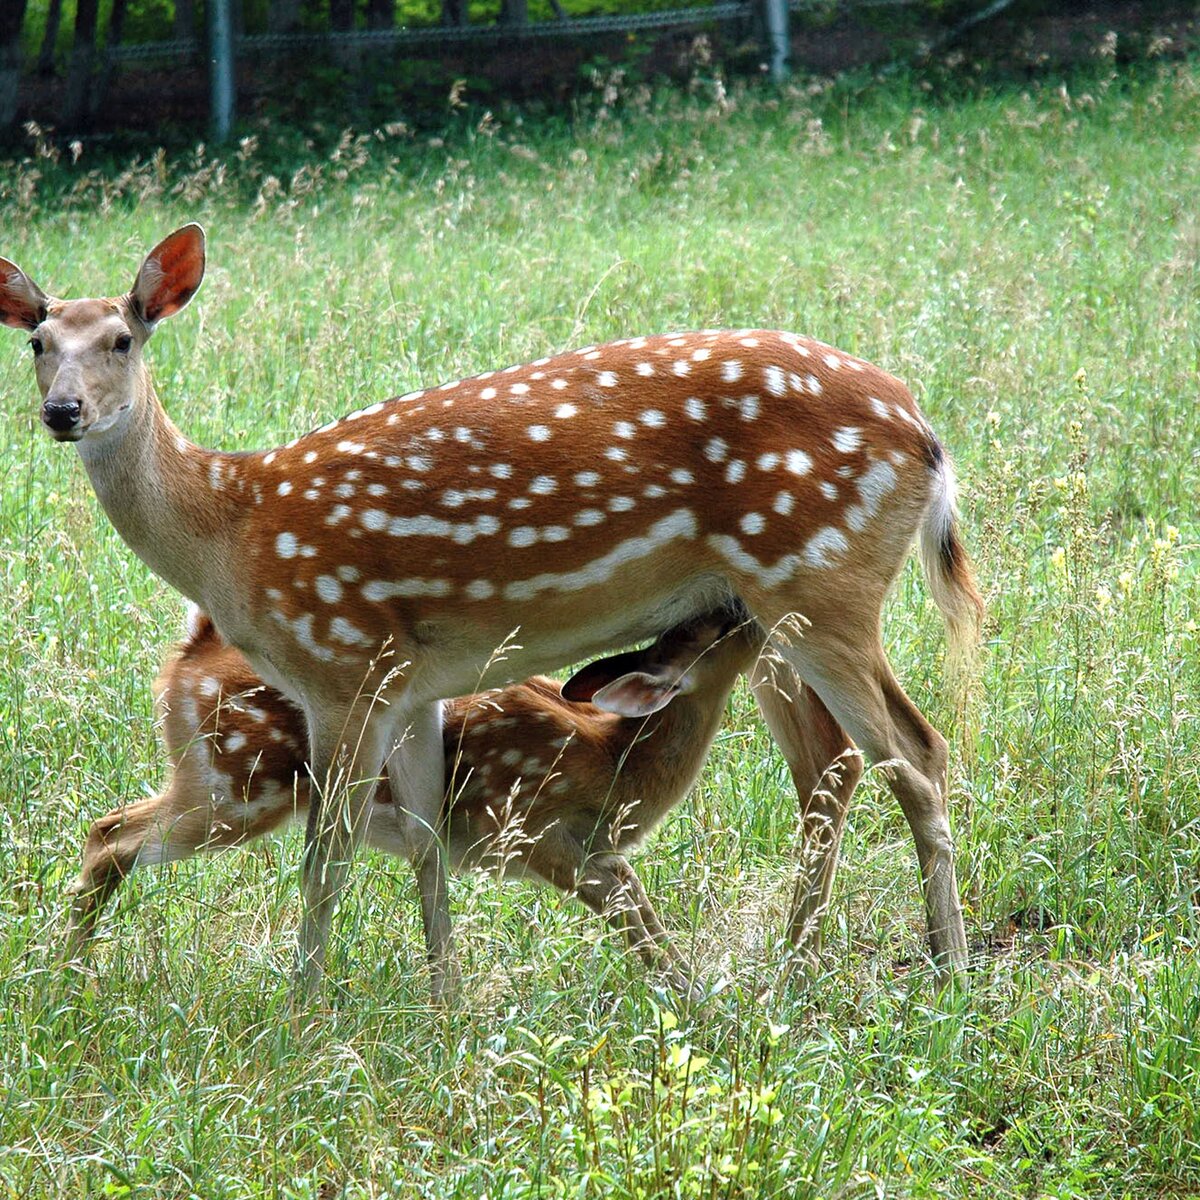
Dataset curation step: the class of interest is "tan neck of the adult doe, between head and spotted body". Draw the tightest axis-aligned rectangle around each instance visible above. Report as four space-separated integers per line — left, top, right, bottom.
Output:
78 368 242 605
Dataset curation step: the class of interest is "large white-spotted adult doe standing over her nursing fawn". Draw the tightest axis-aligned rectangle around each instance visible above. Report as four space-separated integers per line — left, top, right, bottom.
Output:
0 224 980 998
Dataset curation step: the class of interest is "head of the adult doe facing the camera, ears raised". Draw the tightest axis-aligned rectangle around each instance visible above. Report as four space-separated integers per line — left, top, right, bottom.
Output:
0 224 204 442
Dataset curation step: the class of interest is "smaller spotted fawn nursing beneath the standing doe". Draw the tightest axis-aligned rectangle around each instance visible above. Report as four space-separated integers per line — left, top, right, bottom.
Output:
67 610 762 998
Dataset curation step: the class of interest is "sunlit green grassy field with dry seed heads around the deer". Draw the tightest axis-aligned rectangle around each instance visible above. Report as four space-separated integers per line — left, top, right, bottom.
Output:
0 64 1200 1200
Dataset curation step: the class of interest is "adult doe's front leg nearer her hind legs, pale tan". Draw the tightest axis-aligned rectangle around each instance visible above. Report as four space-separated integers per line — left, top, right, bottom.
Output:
388 702 460 1004
